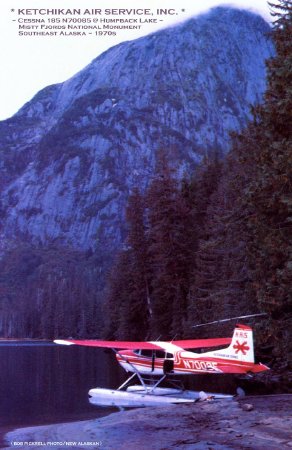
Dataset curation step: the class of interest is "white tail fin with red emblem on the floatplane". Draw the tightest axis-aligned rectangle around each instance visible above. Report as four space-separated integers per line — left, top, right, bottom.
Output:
216 325 254 363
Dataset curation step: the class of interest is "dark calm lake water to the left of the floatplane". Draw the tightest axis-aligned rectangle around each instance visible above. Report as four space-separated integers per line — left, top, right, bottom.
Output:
0 342 125 447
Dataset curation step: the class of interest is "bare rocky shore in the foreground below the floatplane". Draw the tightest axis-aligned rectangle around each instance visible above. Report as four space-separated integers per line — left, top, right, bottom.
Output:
4 394 292 450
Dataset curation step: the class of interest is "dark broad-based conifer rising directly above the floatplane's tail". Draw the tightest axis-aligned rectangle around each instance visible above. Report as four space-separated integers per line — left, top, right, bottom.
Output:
190 155 256 333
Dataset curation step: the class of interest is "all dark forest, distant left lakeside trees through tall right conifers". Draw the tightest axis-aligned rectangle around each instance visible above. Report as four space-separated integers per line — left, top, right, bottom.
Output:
0 0 292 380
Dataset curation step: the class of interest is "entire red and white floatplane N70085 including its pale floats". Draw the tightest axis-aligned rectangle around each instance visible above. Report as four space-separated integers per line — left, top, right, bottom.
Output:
54 316 269 407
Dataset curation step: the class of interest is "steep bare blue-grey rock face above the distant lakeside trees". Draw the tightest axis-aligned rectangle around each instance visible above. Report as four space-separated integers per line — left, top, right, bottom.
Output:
0 8 273 253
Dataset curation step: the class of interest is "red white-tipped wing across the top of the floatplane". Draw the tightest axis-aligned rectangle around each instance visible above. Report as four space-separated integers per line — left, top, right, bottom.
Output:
54 338 231 350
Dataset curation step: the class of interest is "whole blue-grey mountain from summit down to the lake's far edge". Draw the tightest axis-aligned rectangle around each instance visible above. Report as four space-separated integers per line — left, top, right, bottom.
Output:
0 7 274 338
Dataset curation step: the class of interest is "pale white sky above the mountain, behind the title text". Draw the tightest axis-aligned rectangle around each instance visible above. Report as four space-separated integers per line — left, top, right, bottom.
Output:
0 0 271 120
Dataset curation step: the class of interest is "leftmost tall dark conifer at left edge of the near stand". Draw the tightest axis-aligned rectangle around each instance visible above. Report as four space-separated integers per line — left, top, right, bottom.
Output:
105 188 152 340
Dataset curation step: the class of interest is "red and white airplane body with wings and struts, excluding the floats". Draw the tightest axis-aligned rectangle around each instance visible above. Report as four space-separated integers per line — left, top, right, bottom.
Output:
54 325 269 398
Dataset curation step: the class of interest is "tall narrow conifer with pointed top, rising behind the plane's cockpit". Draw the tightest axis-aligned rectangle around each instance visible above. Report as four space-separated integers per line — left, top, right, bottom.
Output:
147 152 191 338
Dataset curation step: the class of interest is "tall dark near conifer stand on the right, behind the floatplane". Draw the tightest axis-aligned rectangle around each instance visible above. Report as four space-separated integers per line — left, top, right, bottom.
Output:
105 1 292 368
